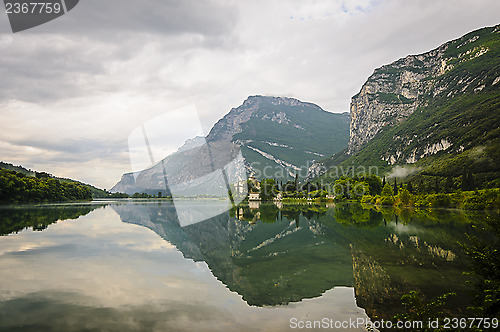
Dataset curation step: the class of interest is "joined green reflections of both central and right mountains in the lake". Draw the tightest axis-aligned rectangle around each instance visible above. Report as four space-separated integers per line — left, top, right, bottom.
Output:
113 202 492 318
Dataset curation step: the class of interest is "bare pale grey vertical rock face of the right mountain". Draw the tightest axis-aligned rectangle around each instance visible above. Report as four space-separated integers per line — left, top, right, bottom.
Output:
348 44 449 154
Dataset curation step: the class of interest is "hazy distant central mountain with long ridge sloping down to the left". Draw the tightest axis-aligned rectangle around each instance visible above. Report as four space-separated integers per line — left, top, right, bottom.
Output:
111 96 349 195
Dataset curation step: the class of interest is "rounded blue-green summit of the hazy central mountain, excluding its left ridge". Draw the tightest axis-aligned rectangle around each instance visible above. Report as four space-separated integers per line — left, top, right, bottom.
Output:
214 96 349 178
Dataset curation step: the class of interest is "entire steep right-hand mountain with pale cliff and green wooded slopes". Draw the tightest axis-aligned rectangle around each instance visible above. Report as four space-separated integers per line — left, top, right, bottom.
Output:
316 25 500 187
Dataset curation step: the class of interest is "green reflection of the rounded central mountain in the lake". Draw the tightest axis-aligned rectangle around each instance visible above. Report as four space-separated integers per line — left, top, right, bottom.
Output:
113 200 353 306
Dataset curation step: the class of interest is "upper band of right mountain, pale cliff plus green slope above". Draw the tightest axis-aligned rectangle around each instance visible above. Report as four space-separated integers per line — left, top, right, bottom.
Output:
348 26 500 156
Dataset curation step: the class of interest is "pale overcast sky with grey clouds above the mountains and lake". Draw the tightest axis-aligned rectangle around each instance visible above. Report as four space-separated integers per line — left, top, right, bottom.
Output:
0 0 500 189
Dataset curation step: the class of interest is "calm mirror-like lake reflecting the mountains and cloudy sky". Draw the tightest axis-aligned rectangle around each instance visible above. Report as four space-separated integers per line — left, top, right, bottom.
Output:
0 200 488 331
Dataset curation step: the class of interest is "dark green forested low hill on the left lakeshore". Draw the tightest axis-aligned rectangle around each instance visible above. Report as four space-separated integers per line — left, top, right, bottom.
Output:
0 169 92 203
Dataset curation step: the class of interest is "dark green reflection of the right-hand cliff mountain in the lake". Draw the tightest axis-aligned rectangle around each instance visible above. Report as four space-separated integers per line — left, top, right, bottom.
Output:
320 204 495 318
